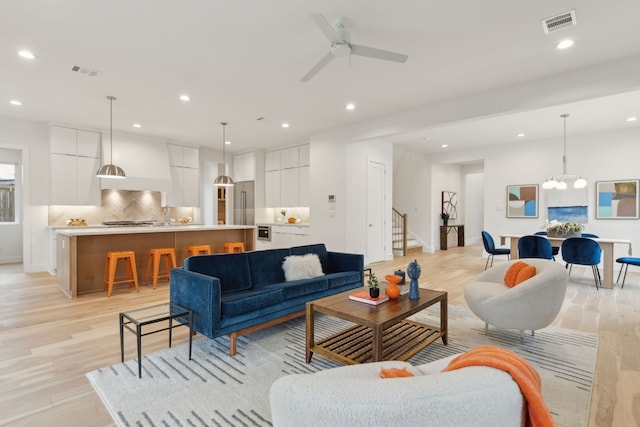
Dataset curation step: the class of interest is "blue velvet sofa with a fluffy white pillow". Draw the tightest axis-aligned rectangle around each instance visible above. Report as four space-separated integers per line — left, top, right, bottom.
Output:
170 244 364 355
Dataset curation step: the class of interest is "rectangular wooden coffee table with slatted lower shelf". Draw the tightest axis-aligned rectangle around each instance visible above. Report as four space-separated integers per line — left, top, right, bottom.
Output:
306 289 447 365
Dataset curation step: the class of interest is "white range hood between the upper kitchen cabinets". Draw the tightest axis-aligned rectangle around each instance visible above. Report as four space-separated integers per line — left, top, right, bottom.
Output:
100 133 171 191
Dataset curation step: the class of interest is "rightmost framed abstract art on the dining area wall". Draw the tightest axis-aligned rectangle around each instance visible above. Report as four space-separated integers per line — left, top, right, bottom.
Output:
596 179 640 219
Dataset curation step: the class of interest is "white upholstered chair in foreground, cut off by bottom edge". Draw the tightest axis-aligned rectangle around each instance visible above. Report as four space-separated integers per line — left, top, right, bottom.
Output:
269 356 525 427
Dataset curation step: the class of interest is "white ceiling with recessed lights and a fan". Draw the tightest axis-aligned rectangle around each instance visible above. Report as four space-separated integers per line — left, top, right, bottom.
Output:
0 0 640 152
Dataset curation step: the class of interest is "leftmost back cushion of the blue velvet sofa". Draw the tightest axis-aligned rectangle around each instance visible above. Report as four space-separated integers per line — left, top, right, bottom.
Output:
184 253 251 294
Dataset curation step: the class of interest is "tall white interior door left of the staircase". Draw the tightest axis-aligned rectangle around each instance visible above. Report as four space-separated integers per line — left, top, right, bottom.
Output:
365 161 386 263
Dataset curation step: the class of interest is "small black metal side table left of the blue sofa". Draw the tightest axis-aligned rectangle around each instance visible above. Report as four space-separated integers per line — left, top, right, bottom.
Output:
120 302 193 378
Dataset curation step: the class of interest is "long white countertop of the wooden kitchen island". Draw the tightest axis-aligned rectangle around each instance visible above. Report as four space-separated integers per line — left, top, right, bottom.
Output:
51 224 255 236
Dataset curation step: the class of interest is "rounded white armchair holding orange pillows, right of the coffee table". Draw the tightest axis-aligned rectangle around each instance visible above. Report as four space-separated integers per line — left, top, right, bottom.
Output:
464 258 568 335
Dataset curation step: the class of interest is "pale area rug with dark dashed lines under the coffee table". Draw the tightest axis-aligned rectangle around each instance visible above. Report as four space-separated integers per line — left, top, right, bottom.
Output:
87 306 598 426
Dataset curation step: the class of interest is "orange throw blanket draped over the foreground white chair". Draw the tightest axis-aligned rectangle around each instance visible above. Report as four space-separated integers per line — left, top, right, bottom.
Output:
443 345 555 427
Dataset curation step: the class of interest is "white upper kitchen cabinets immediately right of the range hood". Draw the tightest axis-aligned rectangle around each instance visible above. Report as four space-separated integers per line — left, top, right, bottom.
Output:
166 144 200 207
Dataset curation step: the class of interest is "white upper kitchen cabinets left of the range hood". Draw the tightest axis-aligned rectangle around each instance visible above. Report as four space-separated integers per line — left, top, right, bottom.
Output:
50 126 101 206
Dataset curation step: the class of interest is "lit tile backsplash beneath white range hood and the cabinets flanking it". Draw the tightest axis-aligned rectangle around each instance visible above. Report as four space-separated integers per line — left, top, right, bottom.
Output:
49 190 196 226
